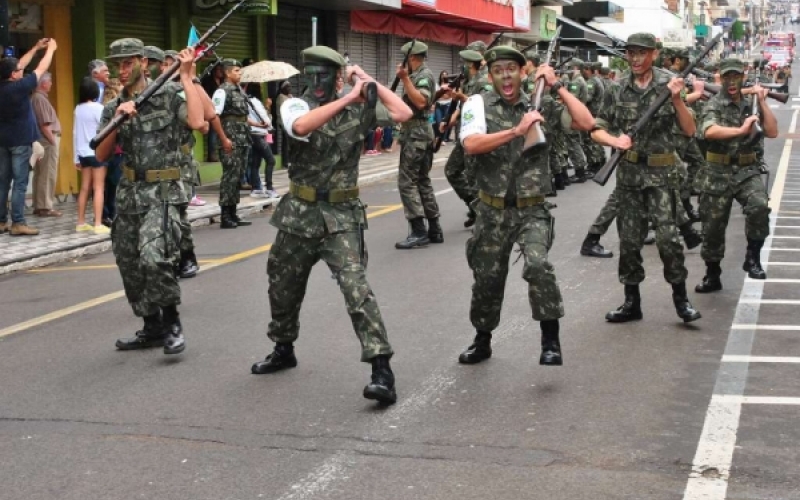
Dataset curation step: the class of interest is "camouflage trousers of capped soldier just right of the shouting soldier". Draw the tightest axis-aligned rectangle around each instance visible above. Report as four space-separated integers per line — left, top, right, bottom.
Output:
615 187 688 285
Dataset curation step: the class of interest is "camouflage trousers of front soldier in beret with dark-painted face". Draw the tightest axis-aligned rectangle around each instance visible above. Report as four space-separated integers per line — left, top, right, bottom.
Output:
267 231 393 362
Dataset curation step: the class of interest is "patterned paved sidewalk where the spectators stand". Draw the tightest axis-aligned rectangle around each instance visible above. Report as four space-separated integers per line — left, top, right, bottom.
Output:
0 144 452 275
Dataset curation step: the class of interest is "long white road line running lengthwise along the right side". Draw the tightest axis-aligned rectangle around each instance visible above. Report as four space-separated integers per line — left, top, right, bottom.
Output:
683 110 800 500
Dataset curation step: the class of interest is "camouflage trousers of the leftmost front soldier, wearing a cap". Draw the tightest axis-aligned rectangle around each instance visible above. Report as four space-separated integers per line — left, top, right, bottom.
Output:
111 205 181 317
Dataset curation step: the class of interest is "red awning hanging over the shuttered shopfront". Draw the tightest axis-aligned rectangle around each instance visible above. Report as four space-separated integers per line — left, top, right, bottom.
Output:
350 10 492 47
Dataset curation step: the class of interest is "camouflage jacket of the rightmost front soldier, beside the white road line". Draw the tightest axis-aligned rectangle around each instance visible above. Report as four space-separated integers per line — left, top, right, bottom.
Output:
695 92 764 194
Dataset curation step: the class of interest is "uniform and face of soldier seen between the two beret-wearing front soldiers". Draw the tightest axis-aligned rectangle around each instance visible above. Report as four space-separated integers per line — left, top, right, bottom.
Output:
397 63 439 220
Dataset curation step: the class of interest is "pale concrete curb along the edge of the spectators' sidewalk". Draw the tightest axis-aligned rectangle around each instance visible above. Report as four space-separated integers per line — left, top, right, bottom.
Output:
0 167 398 276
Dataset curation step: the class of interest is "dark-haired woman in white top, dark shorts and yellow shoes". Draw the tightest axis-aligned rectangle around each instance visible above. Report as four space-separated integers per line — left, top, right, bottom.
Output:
72 77 110 234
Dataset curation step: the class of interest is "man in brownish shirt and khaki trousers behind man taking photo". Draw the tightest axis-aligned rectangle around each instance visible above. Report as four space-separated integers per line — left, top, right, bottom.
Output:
31 72 62 217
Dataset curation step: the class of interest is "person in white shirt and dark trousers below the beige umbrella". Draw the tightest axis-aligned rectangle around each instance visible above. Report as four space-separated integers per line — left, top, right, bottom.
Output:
247 95 279 198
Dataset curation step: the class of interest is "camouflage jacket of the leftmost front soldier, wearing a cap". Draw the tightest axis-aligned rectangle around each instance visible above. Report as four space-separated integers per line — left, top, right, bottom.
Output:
98 85 188 214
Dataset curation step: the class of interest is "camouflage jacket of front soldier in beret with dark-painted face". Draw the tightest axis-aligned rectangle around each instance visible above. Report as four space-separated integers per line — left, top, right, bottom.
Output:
270 91 392 238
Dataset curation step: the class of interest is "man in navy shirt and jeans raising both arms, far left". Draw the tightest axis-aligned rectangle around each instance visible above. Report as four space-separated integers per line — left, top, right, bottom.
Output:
0 38 58 236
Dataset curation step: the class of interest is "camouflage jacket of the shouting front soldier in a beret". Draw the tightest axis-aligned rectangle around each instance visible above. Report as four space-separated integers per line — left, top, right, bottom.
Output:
464 91 572 198
